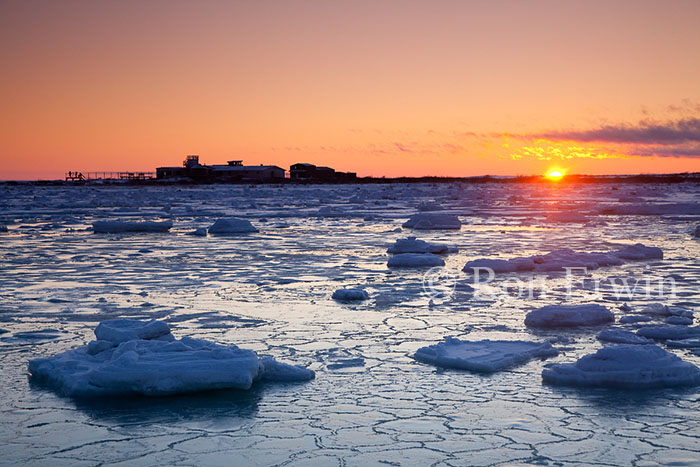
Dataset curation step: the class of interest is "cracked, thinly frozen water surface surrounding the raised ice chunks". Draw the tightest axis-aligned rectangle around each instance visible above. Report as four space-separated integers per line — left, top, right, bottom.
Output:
0 183 700 466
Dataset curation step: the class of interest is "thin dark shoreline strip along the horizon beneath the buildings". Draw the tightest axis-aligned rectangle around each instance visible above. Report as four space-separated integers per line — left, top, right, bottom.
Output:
0 172 700 186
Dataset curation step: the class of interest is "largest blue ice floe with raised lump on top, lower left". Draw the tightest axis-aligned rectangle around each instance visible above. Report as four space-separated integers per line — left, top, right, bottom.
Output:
29 319 314 397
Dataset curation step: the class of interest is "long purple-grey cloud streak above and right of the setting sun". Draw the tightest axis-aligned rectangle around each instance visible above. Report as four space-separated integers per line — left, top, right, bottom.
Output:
530 118 700 146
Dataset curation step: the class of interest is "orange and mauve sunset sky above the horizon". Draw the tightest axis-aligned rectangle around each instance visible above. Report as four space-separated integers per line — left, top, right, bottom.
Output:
0 0 700 180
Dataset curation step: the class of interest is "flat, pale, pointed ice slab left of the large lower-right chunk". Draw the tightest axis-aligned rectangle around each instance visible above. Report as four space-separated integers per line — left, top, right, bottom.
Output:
414 337 558 373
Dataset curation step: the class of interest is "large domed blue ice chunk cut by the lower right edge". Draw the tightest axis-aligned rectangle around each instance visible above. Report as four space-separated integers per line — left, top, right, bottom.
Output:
542 345 700 389
